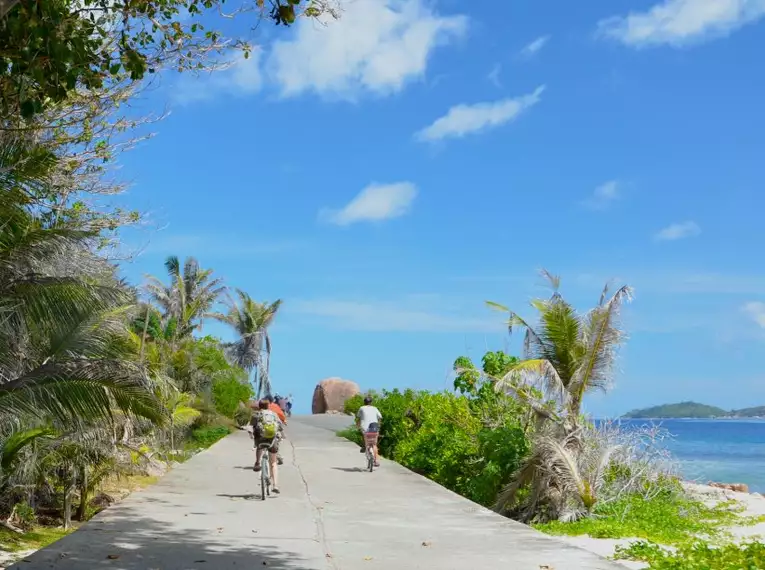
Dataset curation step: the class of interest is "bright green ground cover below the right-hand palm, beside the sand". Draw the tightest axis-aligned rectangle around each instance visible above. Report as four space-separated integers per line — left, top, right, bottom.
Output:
534 489 759 545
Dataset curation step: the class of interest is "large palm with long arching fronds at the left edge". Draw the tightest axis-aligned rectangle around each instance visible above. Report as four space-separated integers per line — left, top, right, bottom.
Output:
0 186 164 422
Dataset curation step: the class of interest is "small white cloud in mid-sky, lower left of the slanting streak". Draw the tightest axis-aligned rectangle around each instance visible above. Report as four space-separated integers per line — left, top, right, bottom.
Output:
319 182 417 226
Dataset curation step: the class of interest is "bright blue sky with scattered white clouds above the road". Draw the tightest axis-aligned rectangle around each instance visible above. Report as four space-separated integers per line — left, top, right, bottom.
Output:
116 0 765 416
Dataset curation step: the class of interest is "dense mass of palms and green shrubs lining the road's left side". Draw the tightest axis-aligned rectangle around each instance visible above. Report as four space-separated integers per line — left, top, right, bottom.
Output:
0 149 271 532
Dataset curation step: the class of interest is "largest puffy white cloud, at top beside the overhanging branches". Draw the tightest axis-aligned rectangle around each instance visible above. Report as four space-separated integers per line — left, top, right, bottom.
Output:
267 0 467 99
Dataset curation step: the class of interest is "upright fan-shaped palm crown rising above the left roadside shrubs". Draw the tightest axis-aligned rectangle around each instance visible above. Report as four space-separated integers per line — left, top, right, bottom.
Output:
146 255 225 338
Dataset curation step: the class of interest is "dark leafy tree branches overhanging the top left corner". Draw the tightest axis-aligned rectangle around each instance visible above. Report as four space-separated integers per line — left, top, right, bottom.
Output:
0 0 334 118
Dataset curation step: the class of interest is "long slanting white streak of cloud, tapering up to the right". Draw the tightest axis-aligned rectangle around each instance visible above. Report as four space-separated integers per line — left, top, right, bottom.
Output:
415 85 545 142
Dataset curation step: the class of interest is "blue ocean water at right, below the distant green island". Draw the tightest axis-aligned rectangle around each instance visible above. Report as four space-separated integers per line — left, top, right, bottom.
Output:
621 420 765 494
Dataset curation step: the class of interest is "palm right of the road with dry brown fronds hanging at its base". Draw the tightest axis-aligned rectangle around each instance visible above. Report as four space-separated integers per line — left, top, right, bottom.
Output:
488 272 632 520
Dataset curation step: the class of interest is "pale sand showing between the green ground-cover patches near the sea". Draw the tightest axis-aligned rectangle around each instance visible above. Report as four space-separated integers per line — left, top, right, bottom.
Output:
558 483 765 569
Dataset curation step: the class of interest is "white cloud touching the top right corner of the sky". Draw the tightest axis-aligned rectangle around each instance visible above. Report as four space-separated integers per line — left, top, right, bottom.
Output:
598 0 765 47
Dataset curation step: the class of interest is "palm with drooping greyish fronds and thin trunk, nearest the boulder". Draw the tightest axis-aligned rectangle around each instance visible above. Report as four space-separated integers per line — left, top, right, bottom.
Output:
214 289 282 398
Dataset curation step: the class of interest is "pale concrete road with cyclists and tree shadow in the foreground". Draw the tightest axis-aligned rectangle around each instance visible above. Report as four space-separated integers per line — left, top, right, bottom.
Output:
12 417 620 570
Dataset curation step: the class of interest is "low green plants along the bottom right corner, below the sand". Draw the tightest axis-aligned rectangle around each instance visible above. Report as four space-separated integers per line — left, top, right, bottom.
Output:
614 541 765 570
